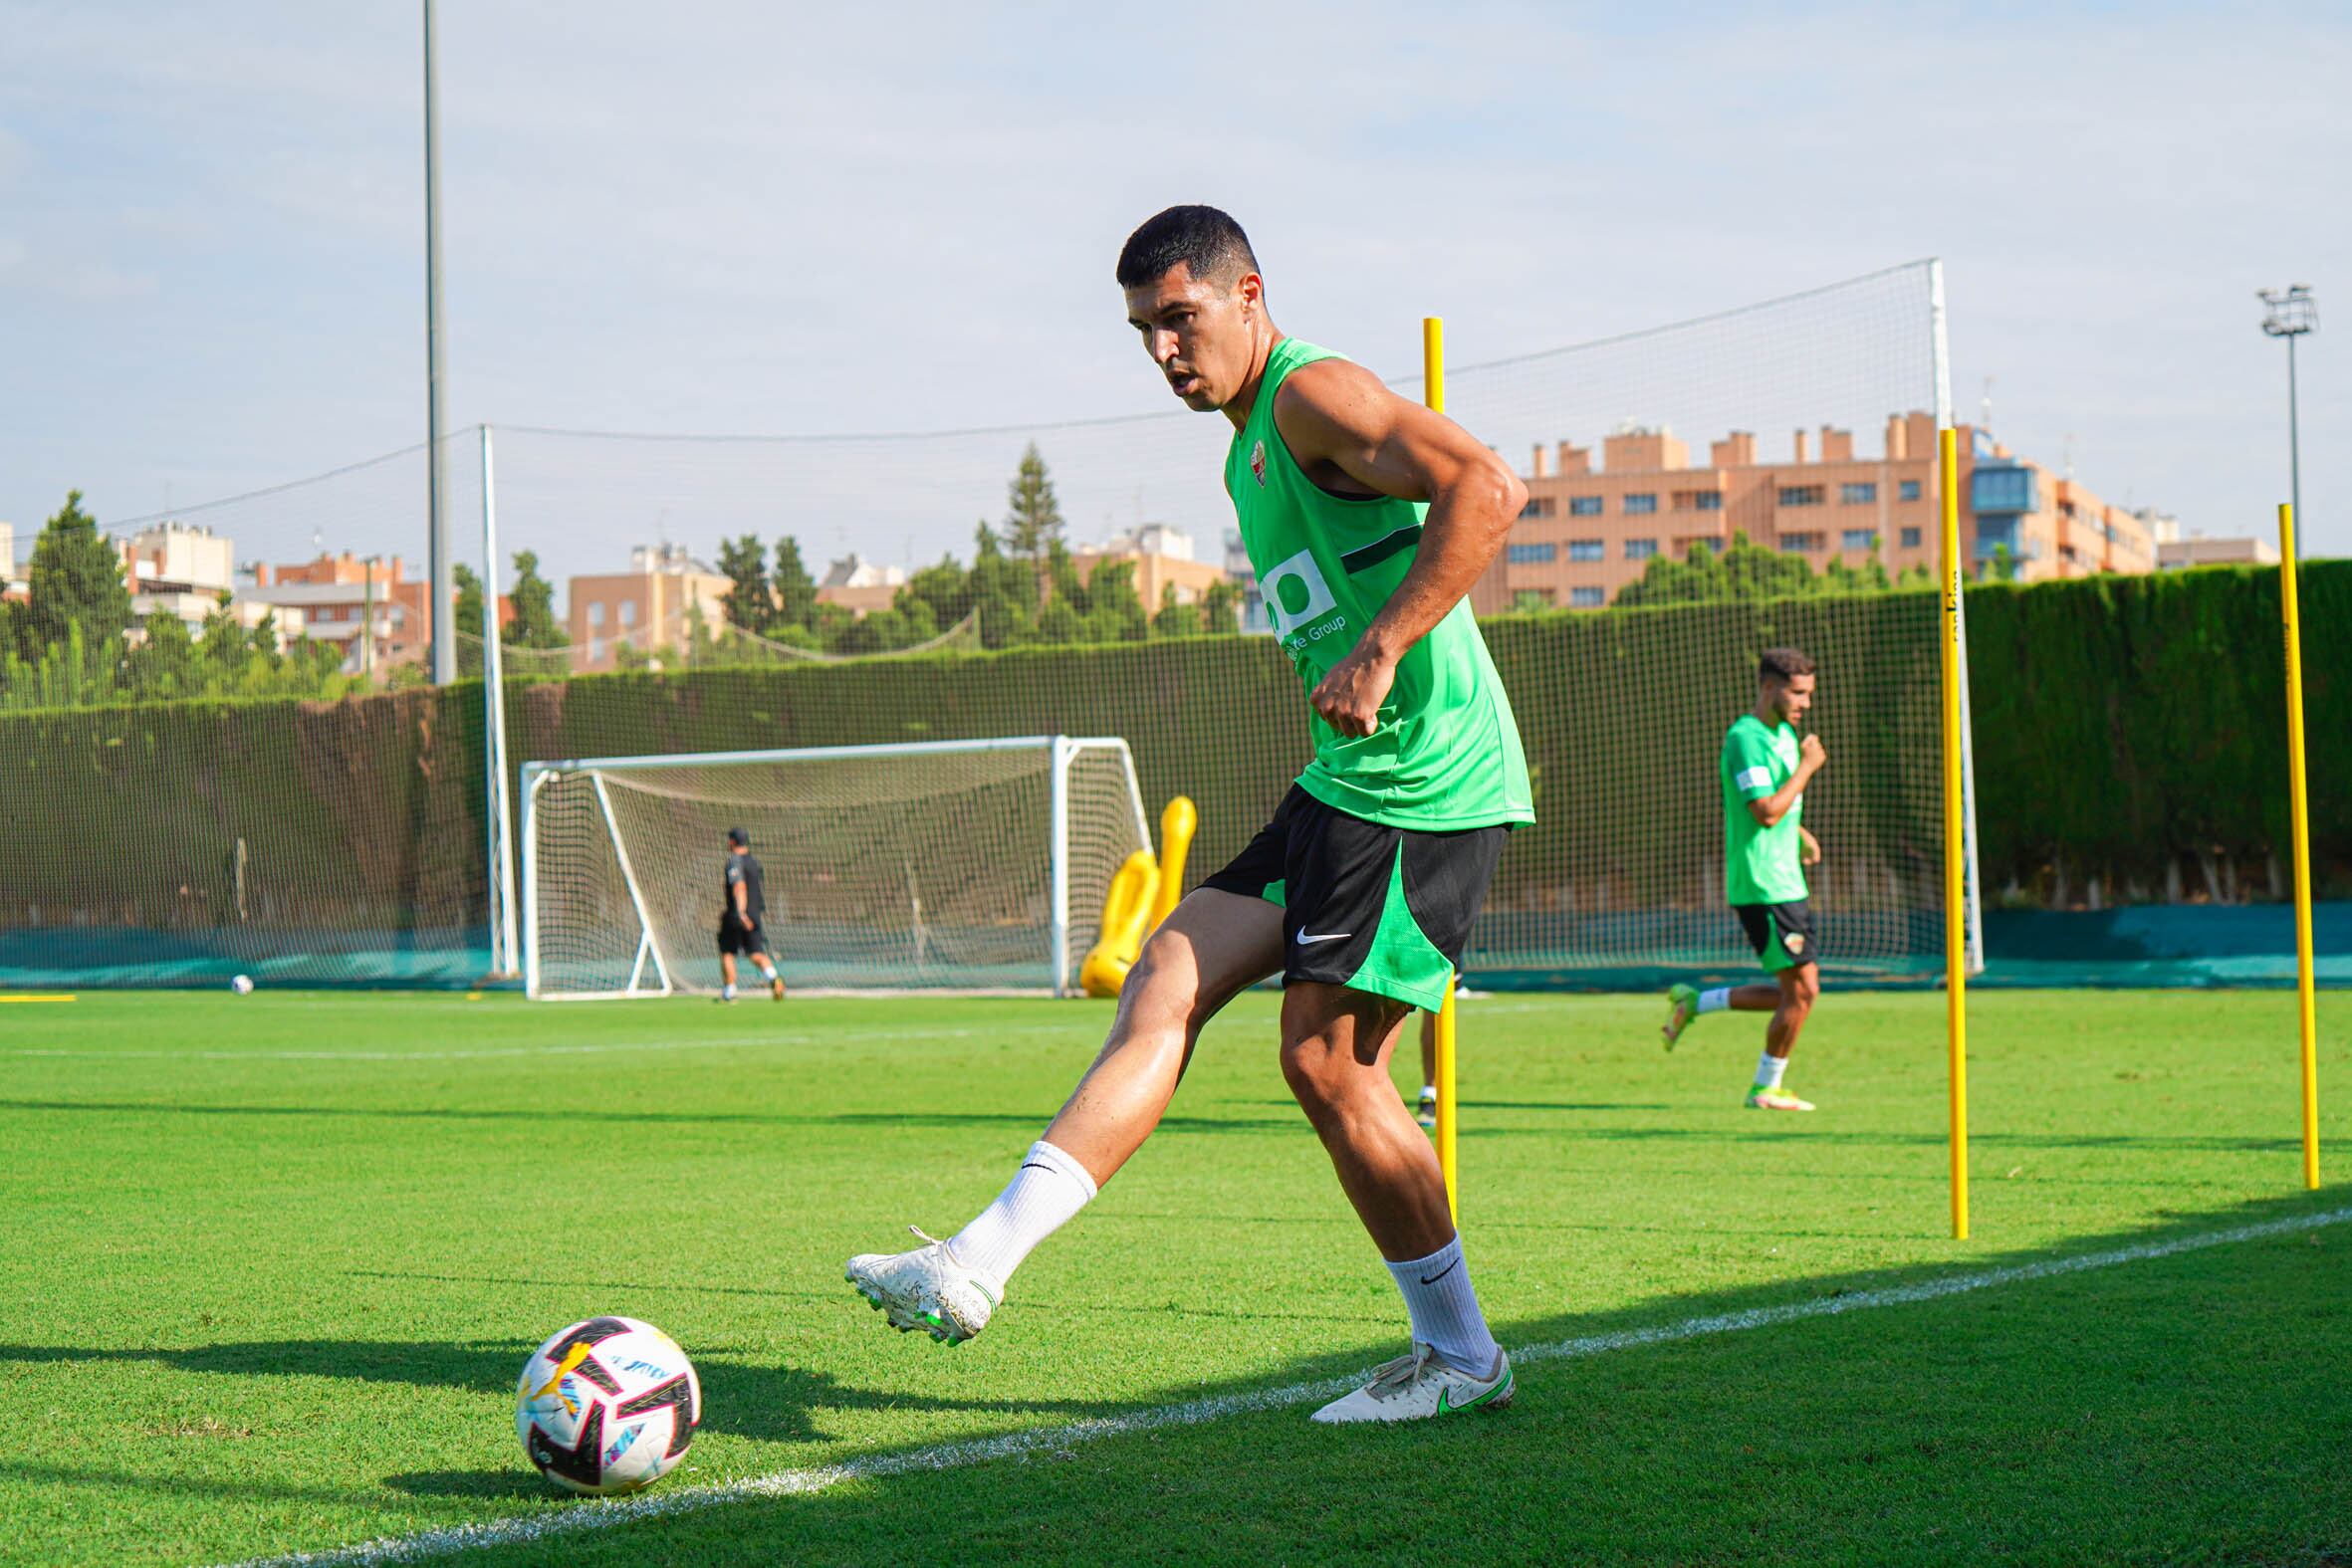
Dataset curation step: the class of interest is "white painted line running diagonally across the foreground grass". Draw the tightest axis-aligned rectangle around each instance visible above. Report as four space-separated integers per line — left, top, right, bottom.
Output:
216 1209 2352 1568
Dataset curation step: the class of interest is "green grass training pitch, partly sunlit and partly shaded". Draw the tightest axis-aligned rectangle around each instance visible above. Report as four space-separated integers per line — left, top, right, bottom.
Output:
0 992 2352 1566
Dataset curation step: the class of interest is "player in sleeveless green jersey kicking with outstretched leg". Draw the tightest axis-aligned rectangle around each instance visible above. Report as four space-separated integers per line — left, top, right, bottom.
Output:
849 207 1535 1423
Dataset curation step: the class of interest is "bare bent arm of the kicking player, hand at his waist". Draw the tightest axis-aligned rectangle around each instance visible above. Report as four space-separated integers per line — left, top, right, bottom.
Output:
1275 359 1527 736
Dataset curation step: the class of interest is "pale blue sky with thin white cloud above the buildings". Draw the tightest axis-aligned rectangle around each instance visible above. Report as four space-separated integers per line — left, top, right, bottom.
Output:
0 0 2352 576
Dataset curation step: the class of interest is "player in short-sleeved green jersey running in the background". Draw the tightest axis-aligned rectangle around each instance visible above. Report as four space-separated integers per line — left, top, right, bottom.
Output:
1663 649 1827 1110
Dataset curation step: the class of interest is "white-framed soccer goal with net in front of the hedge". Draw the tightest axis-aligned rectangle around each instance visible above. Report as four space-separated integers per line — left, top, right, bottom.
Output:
522 736 1150 1000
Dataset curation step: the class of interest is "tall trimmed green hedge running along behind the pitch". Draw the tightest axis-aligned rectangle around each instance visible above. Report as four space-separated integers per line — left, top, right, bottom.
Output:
0 561 2352 941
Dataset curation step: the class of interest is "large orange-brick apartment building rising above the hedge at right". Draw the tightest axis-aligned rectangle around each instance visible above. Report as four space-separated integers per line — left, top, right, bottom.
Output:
1473 411 2157 611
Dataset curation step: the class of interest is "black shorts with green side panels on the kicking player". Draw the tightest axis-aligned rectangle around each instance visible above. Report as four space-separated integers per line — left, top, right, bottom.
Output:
1202 785 1506 1010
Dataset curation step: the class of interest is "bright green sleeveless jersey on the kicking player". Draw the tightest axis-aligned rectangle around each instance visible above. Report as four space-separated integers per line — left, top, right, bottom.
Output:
1226 338 1535 832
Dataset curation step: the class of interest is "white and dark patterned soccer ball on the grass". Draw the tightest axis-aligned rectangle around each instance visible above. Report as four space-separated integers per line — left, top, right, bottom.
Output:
515 1316 703 1497
